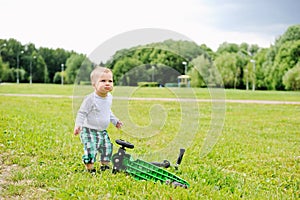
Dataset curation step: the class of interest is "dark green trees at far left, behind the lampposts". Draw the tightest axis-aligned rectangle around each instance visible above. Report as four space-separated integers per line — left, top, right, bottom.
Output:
0 39 86 83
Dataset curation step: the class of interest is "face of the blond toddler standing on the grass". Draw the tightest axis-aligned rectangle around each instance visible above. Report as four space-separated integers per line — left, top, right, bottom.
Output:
94 72 113 97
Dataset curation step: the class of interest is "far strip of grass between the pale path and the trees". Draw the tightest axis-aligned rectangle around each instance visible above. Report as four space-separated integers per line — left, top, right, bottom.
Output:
0 84 300 102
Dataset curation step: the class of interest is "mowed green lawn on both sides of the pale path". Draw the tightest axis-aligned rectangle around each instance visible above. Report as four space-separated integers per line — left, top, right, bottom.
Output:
0 84 300 199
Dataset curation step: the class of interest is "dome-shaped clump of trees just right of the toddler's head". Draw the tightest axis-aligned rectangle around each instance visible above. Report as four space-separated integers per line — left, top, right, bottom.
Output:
107 40 209 86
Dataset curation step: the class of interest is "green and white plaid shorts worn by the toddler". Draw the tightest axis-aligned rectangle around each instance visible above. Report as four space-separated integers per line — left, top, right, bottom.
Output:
80 127 113 164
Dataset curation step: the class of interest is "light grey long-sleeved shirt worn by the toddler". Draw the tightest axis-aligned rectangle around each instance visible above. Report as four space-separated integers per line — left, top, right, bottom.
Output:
75 92 119 131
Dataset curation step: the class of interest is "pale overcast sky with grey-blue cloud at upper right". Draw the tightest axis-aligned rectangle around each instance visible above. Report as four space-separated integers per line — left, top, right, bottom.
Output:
0 0 300 61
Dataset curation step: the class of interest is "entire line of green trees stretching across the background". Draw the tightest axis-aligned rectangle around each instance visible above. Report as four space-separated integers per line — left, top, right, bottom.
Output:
0 25 300 90
